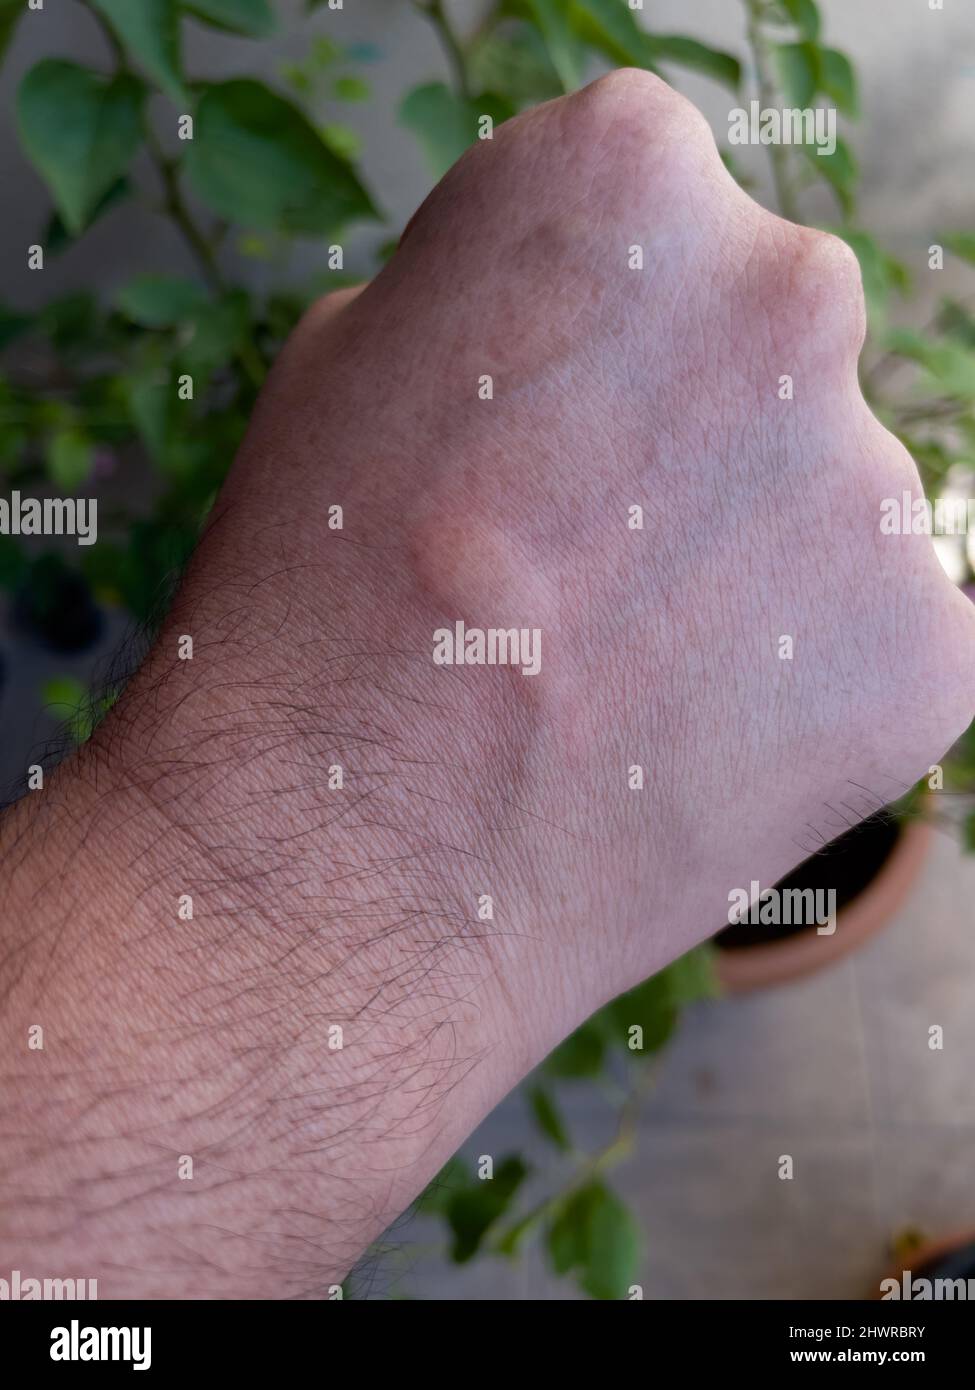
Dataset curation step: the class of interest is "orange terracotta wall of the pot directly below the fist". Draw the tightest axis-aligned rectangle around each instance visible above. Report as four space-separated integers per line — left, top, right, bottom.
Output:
715 820 932 994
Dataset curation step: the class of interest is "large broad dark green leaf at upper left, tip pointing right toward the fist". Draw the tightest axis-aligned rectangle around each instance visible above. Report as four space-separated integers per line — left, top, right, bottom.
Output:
186 78 378 235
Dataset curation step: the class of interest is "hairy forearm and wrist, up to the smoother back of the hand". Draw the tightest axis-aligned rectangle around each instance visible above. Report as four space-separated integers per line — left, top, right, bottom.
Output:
0 525 576 1297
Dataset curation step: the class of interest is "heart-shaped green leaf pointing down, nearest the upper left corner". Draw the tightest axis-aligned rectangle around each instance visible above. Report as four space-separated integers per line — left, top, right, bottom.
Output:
17 58 145 235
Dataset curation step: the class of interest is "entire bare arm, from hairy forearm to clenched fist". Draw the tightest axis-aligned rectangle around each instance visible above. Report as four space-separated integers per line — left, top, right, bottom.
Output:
0 71 975 1298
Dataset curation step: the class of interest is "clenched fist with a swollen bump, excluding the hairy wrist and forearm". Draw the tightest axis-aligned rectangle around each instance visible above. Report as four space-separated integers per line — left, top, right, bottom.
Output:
239 71 975 1000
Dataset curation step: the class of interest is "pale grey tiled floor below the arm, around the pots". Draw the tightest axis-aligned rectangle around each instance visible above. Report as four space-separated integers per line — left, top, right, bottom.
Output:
386 817 975 1300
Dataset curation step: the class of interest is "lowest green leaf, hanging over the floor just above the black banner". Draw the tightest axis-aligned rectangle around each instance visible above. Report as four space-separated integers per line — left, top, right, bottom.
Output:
545 1180 640 1298
